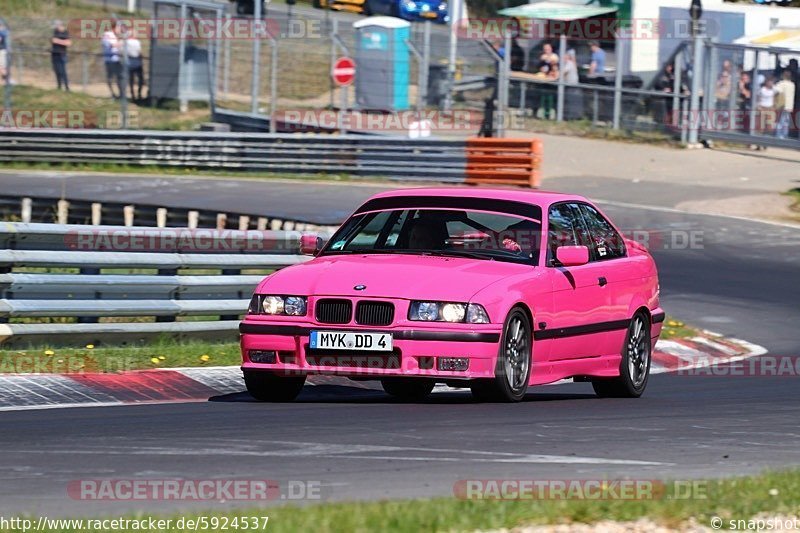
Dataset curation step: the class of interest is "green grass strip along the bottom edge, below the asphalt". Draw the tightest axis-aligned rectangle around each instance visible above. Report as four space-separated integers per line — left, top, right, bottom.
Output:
2 470 800 533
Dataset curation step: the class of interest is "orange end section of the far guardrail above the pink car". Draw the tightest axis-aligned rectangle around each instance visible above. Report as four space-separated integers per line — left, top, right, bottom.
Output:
466 137 543 188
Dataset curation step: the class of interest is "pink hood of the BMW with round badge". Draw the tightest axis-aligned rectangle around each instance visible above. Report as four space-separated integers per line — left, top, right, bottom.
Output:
258 254 534 301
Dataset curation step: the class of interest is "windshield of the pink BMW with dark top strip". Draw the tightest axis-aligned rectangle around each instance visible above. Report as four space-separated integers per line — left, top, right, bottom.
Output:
322 209 541 264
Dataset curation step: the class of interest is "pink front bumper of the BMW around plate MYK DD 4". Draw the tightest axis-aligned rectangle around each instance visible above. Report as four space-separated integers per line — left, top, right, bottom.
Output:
239 320 501 380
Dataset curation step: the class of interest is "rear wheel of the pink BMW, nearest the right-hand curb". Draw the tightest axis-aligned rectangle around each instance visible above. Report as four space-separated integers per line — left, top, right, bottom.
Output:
592 313 652 398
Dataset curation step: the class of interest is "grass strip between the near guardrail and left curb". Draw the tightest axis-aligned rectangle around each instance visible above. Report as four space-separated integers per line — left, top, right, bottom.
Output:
0 333 241 373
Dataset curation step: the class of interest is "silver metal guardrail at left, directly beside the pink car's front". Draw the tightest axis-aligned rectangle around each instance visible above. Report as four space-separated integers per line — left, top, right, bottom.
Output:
0 223 320 347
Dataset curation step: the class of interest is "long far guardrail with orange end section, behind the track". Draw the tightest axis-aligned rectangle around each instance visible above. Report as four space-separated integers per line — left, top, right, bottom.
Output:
0 129 541 186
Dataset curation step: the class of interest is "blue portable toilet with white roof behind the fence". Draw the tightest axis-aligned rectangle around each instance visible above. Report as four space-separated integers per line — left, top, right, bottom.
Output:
353 17 411 111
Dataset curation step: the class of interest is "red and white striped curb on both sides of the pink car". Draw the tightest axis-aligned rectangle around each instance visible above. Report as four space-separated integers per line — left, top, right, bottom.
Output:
0 332 766 411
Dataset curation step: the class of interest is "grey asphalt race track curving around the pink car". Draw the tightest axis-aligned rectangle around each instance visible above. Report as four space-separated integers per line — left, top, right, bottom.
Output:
0 178 800 516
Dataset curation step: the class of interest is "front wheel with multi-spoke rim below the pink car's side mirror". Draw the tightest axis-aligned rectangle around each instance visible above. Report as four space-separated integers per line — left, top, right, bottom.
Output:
470 307 533 402
